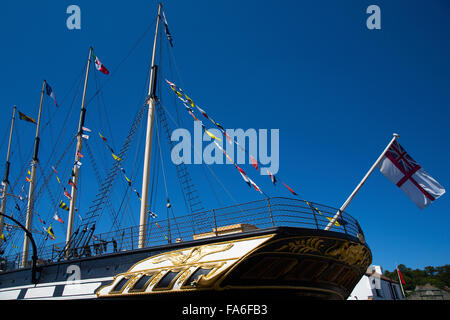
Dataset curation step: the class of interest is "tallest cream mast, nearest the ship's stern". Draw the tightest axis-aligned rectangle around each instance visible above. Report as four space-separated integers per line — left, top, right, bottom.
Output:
138 3 162 248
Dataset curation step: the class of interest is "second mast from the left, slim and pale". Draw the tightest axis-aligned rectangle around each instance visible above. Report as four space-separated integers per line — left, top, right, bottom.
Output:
22 80 46 268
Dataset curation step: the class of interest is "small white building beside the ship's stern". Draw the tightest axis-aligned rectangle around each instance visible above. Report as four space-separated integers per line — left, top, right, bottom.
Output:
347 266 404 300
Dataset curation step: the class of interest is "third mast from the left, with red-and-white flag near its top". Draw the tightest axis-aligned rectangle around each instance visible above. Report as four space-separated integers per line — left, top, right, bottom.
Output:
66 47 93 248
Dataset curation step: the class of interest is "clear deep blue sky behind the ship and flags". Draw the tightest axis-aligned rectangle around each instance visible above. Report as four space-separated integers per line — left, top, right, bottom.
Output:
0 0 450 270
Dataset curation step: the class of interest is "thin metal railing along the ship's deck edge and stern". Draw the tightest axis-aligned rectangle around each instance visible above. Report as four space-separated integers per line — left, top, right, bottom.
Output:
0 197 364 270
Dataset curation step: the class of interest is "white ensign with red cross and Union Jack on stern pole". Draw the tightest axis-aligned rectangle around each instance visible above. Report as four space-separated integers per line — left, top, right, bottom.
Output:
378 141 445 209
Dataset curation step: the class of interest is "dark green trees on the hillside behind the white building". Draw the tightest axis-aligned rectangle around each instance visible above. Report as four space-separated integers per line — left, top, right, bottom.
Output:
384 264 450 291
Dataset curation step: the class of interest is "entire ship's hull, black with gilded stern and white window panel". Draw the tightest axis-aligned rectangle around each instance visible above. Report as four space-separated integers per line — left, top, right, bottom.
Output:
0 227 372 302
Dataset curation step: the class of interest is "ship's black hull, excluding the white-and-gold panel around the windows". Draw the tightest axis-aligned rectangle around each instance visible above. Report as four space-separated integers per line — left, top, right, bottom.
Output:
0 227 372 303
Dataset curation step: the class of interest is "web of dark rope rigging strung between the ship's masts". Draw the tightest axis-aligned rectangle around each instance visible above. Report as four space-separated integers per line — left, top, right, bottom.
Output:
2 3 302 268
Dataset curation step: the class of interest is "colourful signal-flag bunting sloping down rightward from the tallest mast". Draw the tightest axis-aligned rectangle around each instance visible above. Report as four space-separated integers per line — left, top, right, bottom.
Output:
166 79 297 196
